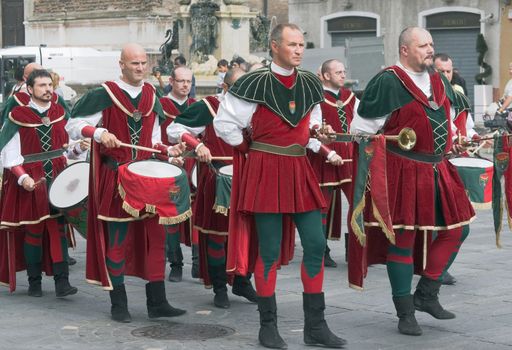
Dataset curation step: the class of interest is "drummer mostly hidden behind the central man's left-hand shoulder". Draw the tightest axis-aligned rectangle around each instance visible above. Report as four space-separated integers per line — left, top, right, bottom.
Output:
167 68 256 309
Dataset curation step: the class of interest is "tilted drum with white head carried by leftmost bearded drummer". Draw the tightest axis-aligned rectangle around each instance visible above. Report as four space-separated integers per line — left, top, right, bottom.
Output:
48 162 89 238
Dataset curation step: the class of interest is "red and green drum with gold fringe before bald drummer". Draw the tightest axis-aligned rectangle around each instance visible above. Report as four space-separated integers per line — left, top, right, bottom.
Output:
118 160 192 225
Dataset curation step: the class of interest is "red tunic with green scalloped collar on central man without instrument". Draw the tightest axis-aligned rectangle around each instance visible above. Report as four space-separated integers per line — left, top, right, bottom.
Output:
214 64 325 275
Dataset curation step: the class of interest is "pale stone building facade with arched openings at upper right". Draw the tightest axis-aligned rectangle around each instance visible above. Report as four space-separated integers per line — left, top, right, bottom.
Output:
289 0 512 103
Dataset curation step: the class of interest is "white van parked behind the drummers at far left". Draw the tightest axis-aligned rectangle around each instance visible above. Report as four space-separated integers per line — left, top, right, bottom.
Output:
0 46 120 103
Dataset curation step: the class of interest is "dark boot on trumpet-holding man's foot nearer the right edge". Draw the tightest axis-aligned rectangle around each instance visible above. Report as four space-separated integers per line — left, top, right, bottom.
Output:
414 276 455 320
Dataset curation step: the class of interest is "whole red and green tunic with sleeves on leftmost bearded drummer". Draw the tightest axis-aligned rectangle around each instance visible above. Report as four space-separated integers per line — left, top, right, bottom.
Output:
0 101 68 291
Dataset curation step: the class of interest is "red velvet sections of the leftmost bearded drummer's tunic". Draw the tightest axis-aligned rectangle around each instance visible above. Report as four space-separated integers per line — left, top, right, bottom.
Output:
0 102 69 227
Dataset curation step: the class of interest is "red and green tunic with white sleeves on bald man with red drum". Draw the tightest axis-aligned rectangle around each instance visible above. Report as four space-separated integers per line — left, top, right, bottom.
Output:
67 82 171 289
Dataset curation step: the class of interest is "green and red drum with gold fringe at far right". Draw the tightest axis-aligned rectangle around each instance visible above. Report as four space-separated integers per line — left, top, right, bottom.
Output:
450 158 493 209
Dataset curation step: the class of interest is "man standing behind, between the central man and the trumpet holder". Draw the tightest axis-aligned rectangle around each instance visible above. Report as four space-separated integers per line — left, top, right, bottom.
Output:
308 59 359 267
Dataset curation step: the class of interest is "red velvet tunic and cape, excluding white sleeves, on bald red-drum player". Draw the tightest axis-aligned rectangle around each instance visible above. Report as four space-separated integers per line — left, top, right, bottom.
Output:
72 82 165 289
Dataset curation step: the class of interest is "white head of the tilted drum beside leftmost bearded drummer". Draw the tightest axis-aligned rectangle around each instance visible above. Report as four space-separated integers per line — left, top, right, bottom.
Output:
48 162 89 209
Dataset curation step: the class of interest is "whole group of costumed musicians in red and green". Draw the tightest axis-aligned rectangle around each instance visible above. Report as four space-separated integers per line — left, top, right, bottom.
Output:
0 24 500 349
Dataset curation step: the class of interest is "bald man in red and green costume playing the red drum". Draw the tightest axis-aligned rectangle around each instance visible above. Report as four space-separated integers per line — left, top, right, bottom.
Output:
66 44 185 322
